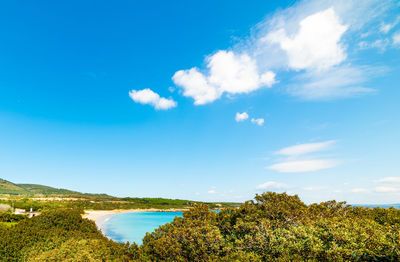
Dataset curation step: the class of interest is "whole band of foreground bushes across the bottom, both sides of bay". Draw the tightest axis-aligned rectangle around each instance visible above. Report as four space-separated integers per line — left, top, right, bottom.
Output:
0 192 400 261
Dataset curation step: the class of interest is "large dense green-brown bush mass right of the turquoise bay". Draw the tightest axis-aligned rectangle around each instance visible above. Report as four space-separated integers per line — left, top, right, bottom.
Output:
141 192 400 261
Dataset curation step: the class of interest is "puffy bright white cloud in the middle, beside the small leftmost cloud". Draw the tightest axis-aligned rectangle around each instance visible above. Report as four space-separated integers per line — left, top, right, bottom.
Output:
172 50 276 105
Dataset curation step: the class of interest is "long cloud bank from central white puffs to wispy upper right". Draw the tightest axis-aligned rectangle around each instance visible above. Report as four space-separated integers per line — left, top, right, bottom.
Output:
172 0 394 105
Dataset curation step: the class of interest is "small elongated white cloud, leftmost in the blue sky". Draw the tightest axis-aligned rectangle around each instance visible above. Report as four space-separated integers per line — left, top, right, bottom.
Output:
129 88 177 110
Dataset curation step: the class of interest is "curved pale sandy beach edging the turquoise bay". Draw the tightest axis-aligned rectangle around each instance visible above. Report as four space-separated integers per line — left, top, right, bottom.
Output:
82 208 189 235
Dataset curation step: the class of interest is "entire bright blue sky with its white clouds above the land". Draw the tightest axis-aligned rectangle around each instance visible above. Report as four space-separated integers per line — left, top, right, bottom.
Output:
0 0 400 204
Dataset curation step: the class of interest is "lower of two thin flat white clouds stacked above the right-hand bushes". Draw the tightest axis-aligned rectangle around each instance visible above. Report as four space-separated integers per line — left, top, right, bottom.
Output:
267 159 340 173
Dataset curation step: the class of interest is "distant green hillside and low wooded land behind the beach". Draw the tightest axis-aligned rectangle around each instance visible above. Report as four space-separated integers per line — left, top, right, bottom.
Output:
0 176 238 211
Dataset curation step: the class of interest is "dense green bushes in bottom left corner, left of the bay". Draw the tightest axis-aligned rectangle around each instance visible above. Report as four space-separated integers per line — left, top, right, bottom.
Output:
0 209 137 261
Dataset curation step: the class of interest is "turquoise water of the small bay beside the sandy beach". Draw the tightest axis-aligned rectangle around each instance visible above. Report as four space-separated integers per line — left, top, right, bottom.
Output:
104 212 182 245
